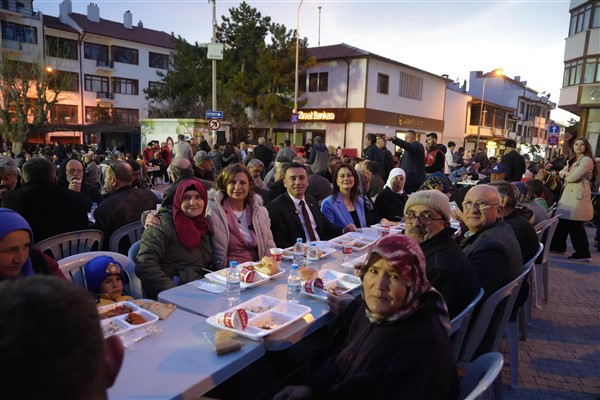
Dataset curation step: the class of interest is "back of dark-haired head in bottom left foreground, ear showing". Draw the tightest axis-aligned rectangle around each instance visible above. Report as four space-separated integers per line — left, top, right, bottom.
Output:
0 276 123 400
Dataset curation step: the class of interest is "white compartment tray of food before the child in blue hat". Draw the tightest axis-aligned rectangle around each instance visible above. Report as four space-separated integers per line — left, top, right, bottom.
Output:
98 301 158 337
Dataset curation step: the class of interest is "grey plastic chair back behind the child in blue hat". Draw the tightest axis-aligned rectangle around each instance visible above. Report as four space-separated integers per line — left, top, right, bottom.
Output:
58 251 143 299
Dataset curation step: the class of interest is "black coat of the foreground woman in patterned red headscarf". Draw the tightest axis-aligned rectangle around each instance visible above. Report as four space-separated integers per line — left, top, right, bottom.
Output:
308 294 458 400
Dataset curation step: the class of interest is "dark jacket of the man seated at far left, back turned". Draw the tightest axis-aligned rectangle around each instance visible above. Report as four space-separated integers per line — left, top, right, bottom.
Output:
0 182 89 243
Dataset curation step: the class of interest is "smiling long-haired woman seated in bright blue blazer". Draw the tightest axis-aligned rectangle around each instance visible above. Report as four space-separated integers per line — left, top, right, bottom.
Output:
321 164 367 230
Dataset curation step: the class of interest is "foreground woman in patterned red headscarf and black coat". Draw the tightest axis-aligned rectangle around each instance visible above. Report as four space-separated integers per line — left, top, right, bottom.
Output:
275 235 458 400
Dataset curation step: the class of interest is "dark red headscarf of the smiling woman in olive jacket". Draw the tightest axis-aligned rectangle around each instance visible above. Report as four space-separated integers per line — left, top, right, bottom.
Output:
173 178 210 250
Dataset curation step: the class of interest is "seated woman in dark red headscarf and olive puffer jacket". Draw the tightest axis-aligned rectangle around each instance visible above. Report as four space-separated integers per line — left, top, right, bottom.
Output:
135 178 212 299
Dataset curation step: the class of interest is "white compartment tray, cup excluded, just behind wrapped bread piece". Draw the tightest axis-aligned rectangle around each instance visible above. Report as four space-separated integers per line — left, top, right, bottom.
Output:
206 295 311 340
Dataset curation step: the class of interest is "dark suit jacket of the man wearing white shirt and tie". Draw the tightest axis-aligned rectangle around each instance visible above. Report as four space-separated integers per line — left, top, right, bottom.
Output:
267 193 342 249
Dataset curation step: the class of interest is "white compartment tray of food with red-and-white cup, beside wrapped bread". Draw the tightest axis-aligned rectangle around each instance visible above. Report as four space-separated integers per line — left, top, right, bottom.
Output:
206 295 311 340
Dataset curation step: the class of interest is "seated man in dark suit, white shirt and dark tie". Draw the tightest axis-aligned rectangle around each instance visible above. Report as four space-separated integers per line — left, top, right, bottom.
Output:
267 162 343 248
